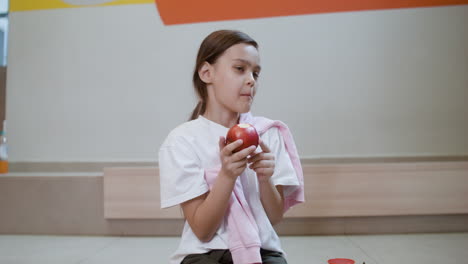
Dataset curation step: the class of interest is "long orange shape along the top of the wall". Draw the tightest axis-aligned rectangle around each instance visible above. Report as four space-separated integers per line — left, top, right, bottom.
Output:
155 0 468 25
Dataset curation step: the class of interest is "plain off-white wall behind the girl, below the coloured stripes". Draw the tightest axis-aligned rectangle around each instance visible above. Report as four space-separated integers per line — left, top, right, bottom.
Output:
7 5 468 162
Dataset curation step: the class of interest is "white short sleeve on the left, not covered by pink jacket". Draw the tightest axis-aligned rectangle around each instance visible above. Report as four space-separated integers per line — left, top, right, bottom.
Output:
159 136 208 208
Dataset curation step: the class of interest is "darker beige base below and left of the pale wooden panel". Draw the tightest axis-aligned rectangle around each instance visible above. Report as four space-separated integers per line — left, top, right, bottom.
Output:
0 176 468 236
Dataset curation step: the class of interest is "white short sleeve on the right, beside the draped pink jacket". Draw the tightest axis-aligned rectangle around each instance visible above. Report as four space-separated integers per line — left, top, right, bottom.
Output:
262 127 300 196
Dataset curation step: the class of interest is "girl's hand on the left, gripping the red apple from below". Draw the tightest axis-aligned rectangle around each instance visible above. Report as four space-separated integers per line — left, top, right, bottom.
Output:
219 137 256 180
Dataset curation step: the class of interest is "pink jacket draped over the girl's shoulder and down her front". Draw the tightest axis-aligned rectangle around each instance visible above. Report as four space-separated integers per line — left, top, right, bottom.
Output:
205 113 304 264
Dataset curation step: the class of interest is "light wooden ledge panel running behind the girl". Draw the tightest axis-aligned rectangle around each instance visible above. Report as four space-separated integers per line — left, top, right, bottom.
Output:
103 161 468 219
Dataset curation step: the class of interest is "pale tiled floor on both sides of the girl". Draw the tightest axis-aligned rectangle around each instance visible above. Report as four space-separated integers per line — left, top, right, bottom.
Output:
0 233 468 264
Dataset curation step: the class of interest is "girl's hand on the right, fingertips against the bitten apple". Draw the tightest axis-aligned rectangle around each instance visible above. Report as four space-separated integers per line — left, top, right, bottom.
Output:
248 140 275 182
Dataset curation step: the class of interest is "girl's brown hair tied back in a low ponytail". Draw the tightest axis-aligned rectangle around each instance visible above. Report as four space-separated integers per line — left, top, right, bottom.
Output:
190 30 258 120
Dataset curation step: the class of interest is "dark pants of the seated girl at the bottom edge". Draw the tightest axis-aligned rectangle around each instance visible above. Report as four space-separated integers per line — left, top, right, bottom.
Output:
181 249 287 264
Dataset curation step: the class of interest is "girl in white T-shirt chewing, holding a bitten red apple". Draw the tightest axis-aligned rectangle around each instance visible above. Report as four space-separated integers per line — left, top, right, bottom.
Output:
159 30 304 264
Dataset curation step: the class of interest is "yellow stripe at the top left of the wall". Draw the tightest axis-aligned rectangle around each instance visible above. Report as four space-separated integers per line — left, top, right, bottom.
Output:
10 0 154 12
